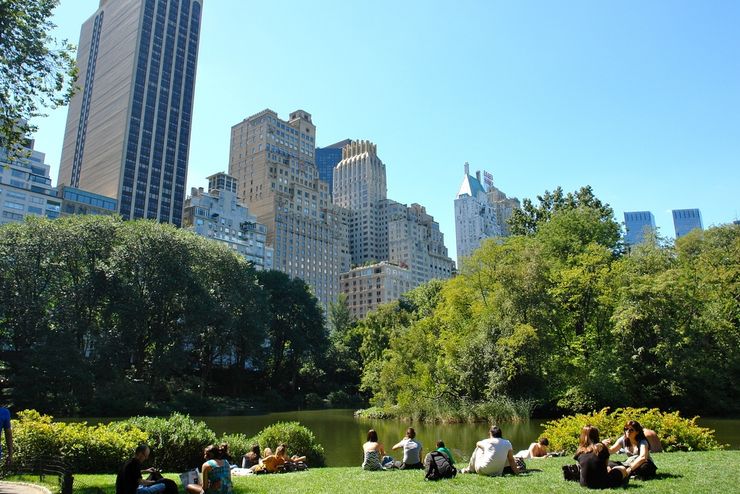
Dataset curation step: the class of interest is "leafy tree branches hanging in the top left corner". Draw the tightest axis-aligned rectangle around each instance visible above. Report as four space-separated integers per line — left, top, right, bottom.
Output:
0 0 77 154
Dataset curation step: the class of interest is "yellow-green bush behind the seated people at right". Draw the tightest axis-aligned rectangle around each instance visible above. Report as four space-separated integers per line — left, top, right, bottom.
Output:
542 408 724 452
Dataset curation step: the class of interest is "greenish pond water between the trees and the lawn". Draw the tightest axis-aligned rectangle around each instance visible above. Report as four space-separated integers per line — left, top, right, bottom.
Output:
67 410 740 467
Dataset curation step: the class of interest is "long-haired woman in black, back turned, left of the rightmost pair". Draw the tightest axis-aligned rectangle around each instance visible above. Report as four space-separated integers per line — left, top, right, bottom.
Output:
573 425 627 489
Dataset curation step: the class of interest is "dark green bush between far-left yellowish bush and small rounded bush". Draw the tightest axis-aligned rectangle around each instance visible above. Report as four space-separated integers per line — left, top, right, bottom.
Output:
118 413 216 472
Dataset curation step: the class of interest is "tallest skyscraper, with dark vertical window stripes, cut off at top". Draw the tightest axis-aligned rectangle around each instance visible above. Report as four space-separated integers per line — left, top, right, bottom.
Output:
59 0 202 226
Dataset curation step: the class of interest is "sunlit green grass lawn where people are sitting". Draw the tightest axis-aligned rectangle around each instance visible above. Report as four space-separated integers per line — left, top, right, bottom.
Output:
14 451 740 494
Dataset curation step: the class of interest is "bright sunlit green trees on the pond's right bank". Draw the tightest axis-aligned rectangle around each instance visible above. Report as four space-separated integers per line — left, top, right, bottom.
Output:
356 187 740 420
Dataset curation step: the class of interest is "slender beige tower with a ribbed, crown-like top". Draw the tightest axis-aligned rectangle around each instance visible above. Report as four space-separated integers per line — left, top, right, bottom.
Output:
333 141 388 265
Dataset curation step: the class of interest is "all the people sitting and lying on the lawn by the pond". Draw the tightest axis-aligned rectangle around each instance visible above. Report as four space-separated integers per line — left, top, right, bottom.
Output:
105 420 660 494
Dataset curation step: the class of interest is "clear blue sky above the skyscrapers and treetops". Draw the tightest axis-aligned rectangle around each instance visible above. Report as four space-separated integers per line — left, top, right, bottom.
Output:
30 0 740 258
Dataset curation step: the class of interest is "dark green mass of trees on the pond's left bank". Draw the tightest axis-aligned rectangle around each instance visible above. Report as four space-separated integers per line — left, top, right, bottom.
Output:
0 216 332 416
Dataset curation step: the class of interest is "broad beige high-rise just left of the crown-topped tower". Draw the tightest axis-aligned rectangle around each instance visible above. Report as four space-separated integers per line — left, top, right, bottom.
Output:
229 109 350 307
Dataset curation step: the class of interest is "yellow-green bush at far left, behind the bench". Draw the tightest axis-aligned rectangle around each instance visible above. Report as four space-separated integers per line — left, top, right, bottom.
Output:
13 410 149 473
